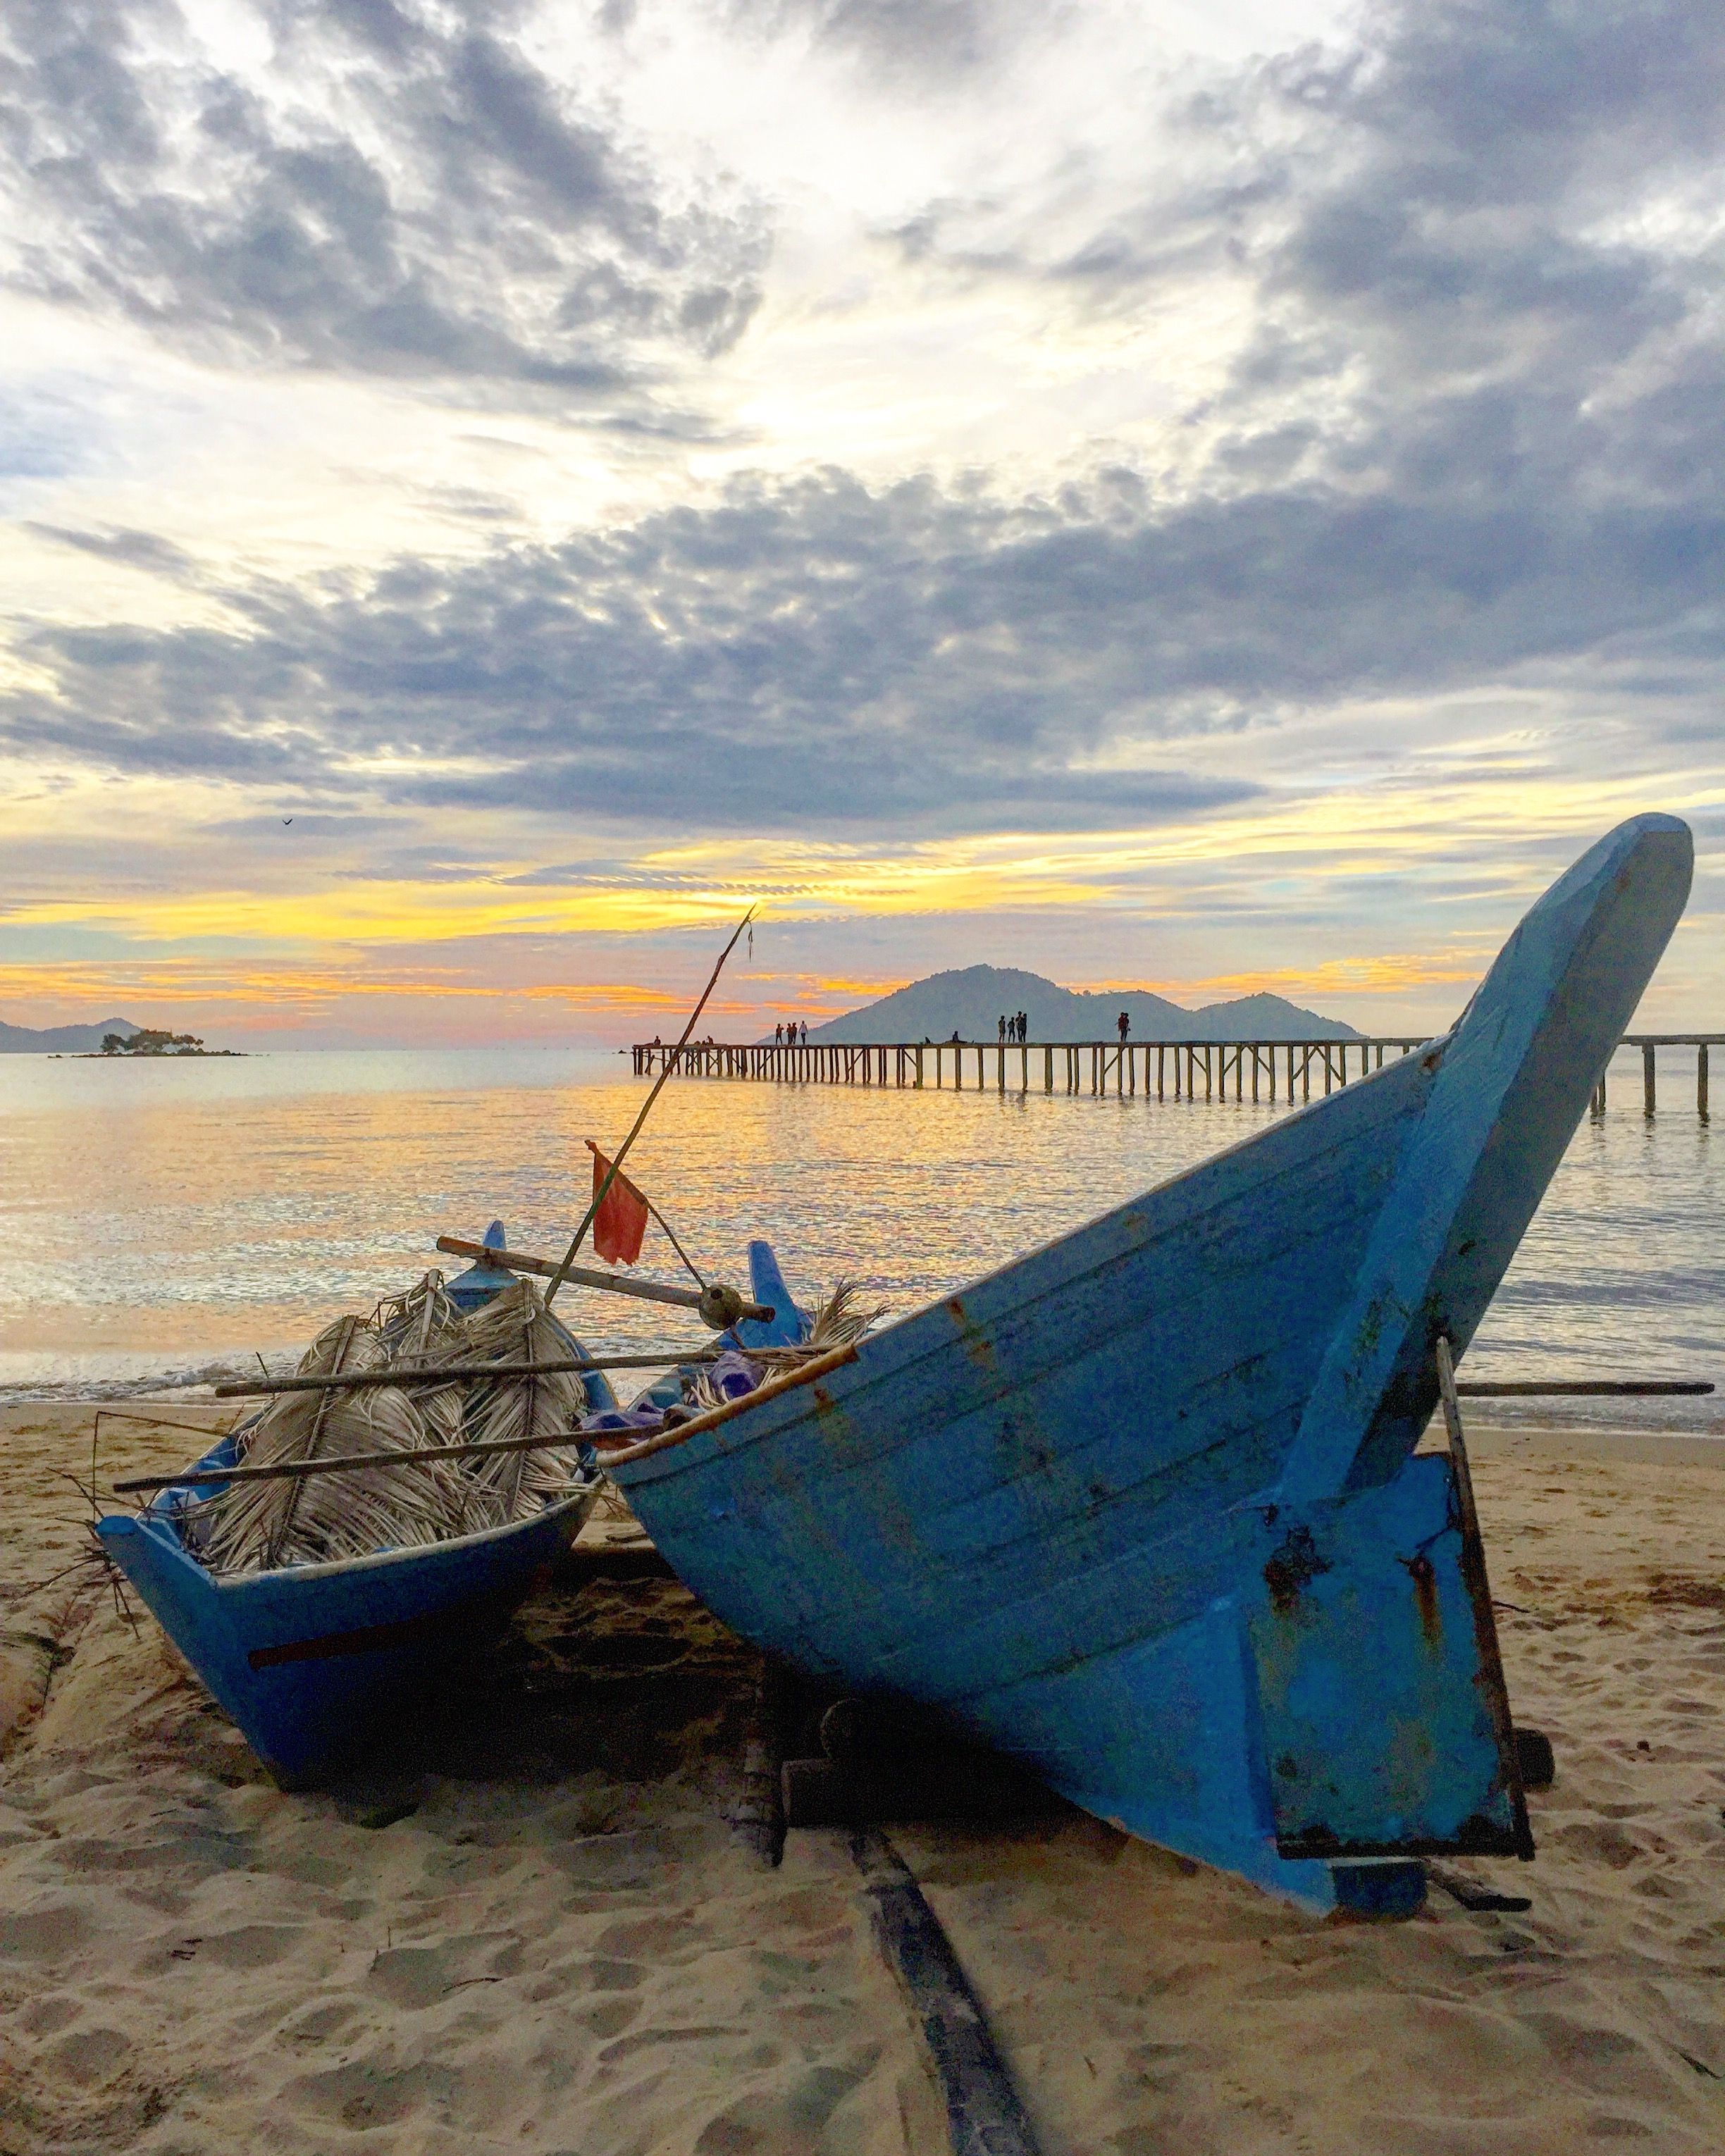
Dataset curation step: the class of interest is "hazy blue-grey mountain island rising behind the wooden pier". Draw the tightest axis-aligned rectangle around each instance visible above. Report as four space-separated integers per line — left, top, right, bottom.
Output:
793 966 1361 1041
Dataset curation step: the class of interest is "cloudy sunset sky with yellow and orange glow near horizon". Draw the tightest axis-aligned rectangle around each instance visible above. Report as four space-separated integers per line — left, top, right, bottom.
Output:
0 0 1725 1046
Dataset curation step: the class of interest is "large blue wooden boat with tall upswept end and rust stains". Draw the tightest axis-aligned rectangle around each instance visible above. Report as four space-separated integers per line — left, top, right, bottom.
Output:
612 815 1693 1908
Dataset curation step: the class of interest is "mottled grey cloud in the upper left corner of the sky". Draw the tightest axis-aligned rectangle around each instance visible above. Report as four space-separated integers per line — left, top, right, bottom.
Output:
0 0 763 401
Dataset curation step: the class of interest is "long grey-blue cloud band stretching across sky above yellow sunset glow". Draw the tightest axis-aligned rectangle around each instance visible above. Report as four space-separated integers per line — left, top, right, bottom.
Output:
4 433 1725 832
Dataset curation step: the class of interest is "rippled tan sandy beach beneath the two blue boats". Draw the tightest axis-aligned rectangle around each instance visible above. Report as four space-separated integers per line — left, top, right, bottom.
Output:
0 1404 1725 2156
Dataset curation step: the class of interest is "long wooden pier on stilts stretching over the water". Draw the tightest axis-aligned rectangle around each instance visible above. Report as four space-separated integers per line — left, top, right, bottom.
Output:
634 1033 1725 1121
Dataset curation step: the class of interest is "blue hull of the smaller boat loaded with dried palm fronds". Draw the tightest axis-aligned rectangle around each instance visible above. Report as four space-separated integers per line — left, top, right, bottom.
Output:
97 1222 614 1788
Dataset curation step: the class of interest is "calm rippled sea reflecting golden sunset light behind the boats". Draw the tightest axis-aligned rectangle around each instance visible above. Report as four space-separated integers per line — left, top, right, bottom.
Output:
0 1048 1725 1438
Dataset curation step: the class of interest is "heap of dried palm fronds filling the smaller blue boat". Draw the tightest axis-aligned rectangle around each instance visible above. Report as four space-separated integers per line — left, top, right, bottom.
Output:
183 1272 586 1574
